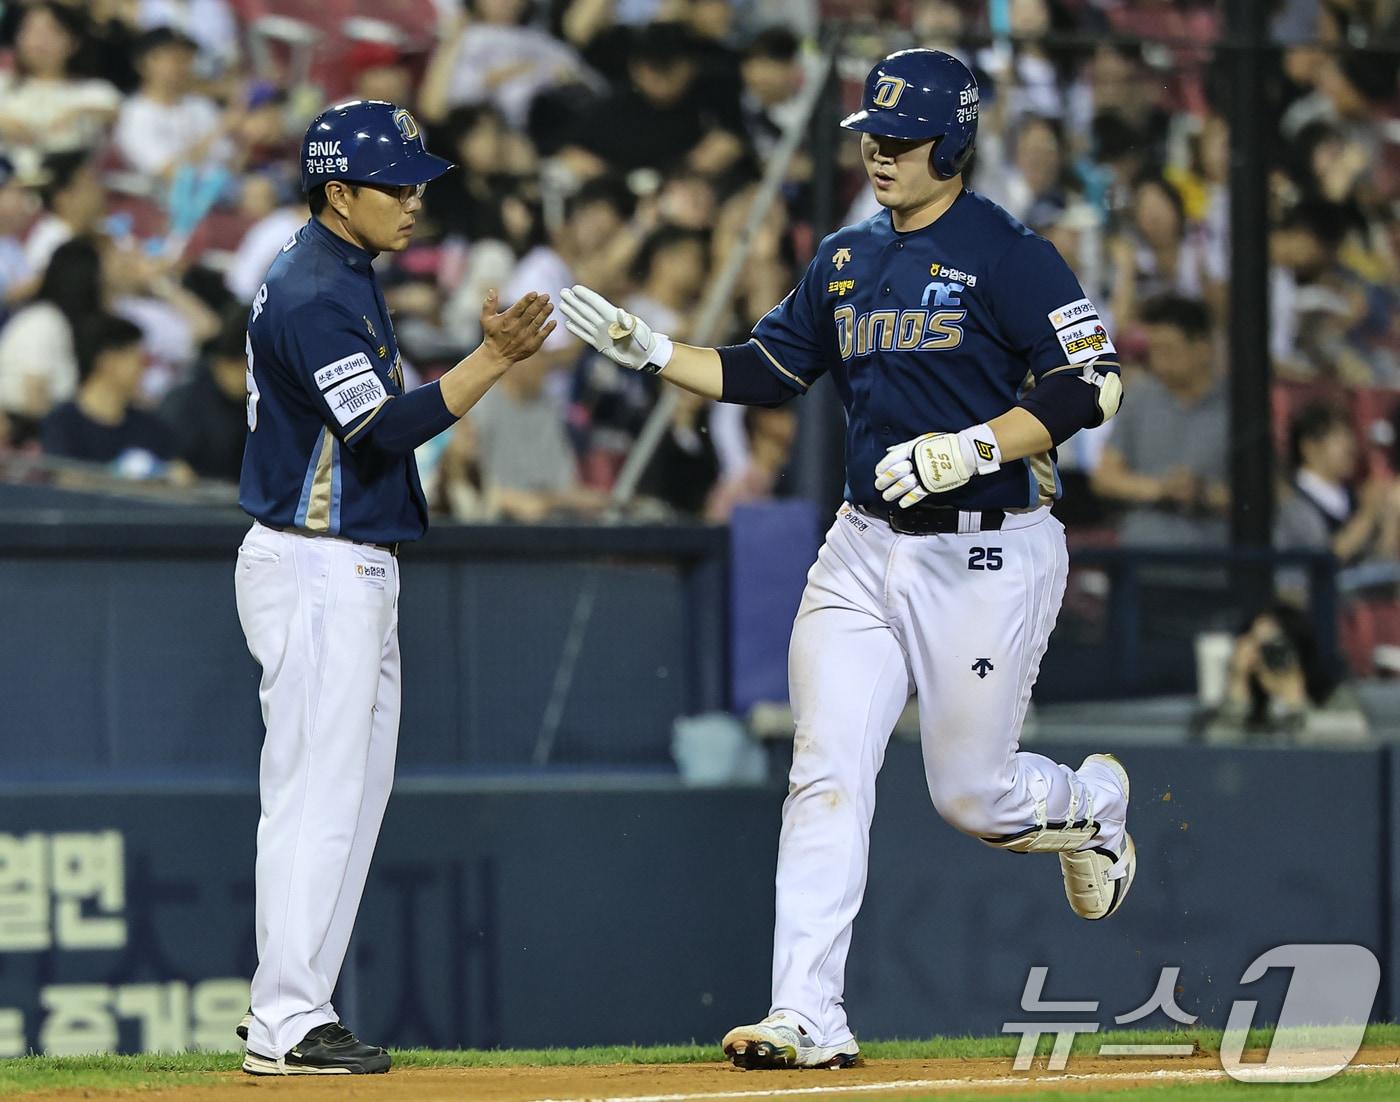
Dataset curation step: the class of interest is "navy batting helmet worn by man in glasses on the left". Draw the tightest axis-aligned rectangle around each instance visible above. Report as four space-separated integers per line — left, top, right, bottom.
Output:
301 99 452 192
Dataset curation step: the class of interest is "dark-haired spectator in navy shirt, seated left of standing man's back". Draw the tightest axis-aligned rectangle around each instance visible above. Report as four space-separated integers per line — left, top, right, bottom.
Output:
39 315 189 480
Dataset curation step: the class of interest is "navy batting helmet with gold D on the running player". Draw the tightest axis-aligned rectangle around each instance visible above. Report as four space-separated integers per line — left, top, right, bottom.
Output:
841 49 979 178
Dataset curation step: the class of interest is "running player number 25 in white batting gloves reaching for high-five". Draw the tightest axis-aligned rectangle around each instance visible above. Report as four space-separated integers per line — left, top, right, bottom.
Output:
561 49 1135 1068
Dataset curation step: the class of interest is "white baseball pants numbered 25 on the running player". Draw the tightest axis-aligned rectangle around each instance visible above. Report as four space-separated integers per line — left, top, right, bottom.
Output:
771 504 1126 1045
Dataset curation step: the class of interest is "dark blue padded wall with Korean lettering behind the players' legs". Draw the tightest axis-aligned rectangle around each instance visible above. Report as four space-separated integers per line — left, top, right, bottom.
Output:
0 744 1383 1054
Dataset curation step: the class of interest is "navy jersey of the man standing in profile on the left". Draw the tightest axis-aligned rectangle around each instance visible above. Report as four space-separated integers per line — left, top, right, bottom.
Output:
238 218 428 543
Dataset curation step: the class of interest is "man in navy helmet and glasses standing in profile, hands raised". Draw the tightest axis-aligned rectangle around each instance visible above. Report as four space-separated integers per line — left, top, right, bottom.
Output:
235 99 554 1075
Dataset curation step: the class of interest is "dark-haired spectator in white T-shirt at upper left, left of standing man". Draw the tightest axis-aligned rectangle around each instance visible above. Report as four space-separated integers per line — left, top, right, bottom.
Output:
115 27 231 183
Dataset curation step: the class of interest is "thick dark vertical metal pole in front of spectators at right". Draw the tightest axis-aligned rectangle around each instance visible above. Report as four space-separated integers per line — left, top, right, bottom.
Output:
1221 0 1274 608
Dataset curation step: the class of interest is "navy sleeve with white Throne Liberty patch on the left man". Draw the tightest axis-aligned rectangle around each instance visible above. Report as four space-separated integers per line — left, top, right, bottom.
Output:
277 301 398 447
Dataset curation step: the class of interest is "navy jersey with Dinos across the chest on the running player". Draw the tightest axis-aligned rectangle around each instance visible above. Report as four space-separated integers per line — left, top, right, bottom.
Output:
753 192 1119 511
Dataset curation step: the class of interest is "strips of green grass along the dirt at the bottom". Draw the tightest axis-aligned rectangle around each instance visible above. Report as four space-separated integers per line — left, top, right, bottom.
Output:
0 1025 1400 1102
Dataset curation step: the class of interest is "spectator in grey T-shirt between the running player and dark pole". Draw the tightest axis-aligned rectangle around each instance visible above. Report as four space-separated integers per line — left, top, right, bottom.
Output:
1091 294 1229 547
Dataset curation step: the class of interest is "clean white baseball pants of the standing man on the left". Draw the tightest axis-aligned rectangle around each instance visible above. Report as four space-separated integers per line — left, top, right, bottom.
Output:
235 524 399 1057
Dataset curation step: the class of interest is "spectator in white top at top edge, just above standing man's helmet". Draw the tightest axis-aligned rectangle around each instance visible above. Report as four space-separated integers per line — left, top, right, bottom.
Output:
419 0 593 130
